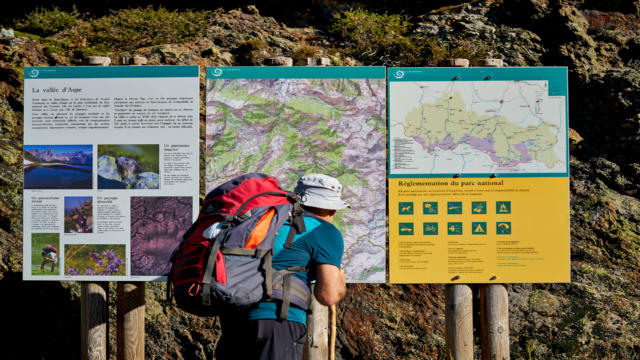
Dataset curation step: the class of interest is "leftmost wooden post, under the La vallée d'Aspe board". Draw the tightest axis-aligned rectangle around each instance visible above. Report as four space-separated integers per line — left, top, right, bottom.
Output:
80 282 109 360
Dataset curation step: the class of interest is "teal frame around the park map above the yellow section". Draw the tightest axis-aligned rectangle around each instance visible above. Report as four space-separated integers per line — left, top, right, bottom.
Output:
387 66 569 179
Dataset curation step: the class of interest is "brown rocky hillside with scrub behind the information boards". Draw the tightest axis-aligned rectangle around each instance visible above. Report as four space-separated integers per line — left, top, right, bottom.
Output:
0 0 640 359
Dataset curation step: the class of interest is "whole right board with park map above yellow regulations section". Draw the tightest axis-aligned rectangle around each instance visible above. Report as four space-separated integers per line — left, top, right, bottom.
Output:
388 67 570 283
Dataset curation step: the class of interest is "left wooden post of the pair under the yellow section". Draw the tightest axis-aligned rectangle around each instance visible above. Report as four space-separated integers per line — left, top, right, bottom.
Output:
445 285 473 360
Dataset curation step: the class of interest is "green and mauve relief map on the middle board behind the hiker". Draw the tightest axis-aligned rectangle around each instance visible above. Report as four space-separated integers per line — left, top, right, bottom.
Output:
206 79 386 283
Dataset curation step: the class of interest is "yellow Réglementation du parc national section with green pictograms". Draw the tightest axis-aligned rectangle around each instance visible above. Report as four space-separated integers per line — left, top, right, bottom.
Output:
389 177 571 284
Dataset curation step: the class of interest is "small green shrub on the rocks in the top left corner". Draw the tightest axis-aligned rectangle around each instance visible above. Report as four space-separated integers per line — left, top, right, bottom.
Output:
14 6 82 36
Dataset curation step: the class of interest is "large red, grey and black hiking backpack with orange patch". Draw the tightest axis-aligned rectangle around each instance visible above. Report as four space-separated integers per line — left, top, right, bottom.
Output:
167 173 311 319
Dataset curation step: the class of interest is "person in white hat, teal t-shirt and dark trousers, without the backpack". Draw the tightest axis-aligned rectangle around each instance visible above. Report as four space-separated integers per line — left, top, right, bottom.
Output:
216 174 348 360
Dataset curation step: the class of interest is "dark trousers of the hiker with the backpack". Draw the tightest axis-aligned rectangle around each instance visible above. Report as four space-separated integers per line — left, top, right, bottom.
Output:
216 316 307 360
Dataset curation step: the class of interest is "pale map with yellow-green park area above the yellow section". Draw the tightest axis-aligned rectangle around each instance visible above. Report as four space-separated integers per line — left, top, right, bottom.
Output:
389 80 567 174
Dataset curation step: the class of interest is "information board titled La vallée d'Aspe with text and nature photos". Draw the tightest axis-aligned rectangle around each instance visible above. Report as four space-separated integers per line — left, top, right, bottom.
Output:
23 66 199 281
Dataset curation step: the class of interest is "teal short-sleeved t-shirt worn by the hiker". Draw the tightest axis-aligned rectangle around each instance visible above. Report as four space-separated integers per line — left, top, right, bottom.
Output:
249 216 344 326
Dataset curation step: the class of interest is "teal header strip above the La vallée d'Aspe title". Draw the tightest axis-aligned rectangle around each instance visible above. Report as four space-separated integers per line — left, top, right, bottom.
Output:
24 65 200 80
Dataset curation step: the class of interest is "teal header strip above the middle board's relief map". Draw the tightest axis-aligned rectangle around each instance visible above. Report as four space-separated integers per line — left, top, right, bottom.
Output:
207 66 387 79
